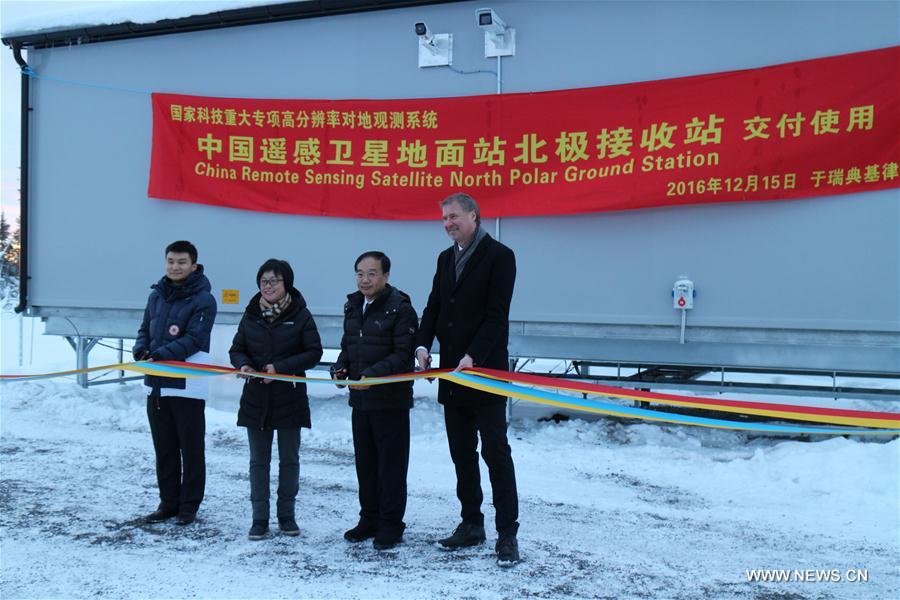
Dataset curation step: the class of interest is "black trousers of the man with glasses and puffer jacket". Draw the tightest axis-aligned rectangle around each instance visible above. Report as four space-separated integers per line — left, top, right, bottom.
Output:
352 408 409 535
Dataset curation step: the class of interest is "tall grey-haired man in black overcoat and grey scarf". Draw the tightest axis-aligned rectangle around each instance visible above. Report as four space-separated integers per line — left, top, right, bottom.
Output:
416 193 519 567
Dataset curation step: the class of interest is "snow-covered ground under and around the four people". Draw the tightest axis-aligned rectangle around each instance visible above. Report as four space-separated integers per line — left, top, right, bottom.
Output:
0 313 900 599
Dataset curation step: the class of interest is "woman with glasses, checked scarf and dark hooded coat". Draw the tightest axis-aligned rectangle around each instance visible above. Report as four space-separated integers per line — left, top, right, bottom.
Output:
229 258 322 540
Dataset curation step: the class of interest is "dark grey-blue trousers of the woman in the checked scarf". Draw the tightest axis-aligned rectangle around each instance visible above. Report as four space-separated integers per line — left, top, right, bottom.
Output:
247 427 300 521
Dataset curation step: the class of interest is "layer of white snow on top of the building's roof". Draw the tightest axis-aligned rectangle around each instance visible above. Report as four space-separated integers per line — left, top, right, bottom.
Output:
0 0 297 38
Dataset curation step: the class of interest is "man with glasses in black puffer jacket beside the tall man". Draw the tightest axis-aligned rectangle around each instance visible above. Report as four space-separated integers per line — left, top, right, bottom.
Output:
332 251 418 550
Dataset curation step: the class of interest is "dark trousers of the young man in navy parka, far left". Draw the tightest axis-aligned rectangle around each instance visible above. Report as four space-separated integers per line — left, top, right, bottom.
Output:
147 395 206 512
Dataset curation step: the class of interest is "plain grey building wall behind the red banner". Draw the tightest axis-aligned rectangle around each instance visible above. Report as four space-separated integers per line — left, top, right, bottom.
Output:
21 1 900 372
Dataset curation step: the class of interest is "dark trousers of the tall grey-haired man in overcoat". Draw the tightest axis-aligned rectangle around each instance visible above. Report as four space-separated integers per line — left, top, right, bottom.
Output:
444 402 519 534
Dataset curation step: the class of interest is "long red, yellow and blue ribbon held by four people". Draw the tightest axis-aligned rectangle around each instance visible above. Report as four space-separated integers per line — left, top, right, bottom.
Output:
0 361 900 435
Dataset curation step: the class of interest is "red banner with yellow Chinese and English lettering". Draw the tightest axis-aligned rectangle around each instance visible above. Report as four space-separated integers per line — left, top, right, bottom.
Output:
149 46 900 219
